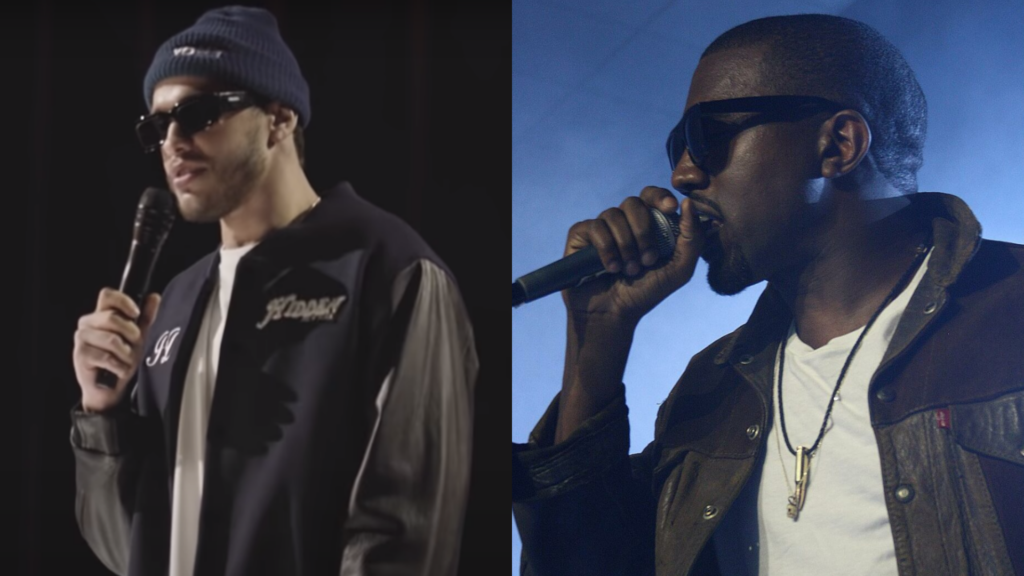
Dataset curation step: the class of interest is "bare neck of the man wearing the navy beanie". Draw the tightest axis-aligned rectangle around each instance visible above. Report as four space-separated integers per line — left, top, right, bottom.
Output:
220 158 318 248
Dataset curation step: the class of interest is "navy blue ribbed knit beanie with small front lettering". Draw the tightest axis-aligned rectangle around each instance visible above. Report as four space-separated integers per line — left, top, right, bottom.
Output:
142 6 310 127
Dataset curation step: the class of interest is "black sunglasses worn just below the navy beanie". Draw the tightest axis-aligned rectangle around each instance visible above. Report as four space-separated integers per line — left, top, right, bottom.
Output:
135 92 256 152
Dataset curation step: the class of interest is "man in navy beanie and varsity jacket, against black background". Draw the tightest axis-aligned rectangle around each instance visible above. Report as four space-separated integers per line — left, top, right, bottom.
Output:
71 6 477 576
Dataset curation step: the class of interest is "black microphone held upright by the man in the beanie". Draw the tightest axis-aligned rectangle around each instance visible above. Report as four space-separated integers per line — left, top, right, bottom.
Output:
96 188 177 388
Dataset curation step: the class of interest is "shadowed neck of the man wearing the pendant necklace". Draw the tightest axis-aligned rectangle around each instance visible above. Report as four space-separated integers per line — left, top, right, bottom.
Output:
772 192 927 348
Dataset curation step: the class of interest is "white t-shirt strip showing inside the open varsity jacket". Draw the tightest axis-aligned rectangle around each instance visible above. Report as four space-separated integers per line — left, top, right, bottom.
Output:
170 244 256 576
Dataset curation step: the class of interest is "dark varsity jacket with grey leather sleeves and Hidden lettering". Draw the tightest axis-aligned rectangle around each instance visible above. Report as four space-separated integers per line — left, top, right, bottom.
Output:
71 183 477 576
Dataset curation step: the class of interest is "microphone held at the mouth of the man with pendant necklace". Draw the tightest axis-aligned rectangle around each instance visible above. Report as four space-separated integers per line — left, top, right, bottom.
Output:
512 208 679 307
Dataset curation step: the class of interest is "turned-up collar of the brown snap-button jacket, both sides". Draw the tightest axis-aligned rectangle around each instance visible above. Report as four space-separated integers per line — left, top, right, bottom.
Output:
715 193 981 365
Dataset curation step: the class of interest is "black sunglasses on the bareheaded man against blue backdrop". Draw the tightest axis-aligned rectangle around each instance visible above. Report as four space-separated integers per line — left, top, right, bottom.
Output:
665 96 850 172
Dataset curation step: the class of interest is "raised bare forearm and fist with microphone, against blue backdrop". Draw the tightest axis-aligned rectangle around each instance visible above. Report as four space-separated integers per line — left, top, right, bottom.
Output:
512 187 705 443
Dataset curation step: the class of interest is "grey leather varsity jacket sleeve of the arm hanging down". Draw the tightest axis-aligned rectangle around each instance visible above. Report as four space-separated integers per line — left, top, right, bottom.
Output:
340 259 478 576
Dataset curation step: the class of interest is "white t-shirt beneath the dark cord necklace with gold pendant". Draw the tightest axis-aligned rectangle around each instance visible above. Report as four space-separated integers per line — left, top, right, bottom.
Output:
715 249 931 576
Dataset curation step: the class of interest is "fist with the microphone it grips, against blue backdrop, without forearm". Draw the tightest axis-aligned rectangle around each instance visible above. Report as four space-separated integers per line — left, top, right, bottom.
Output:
513 187 703 323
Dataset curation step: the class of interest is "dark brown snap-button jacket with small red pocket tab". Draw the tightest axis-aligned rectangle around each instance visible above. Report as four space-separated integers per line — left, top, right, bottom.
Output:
512 194 1024 576
